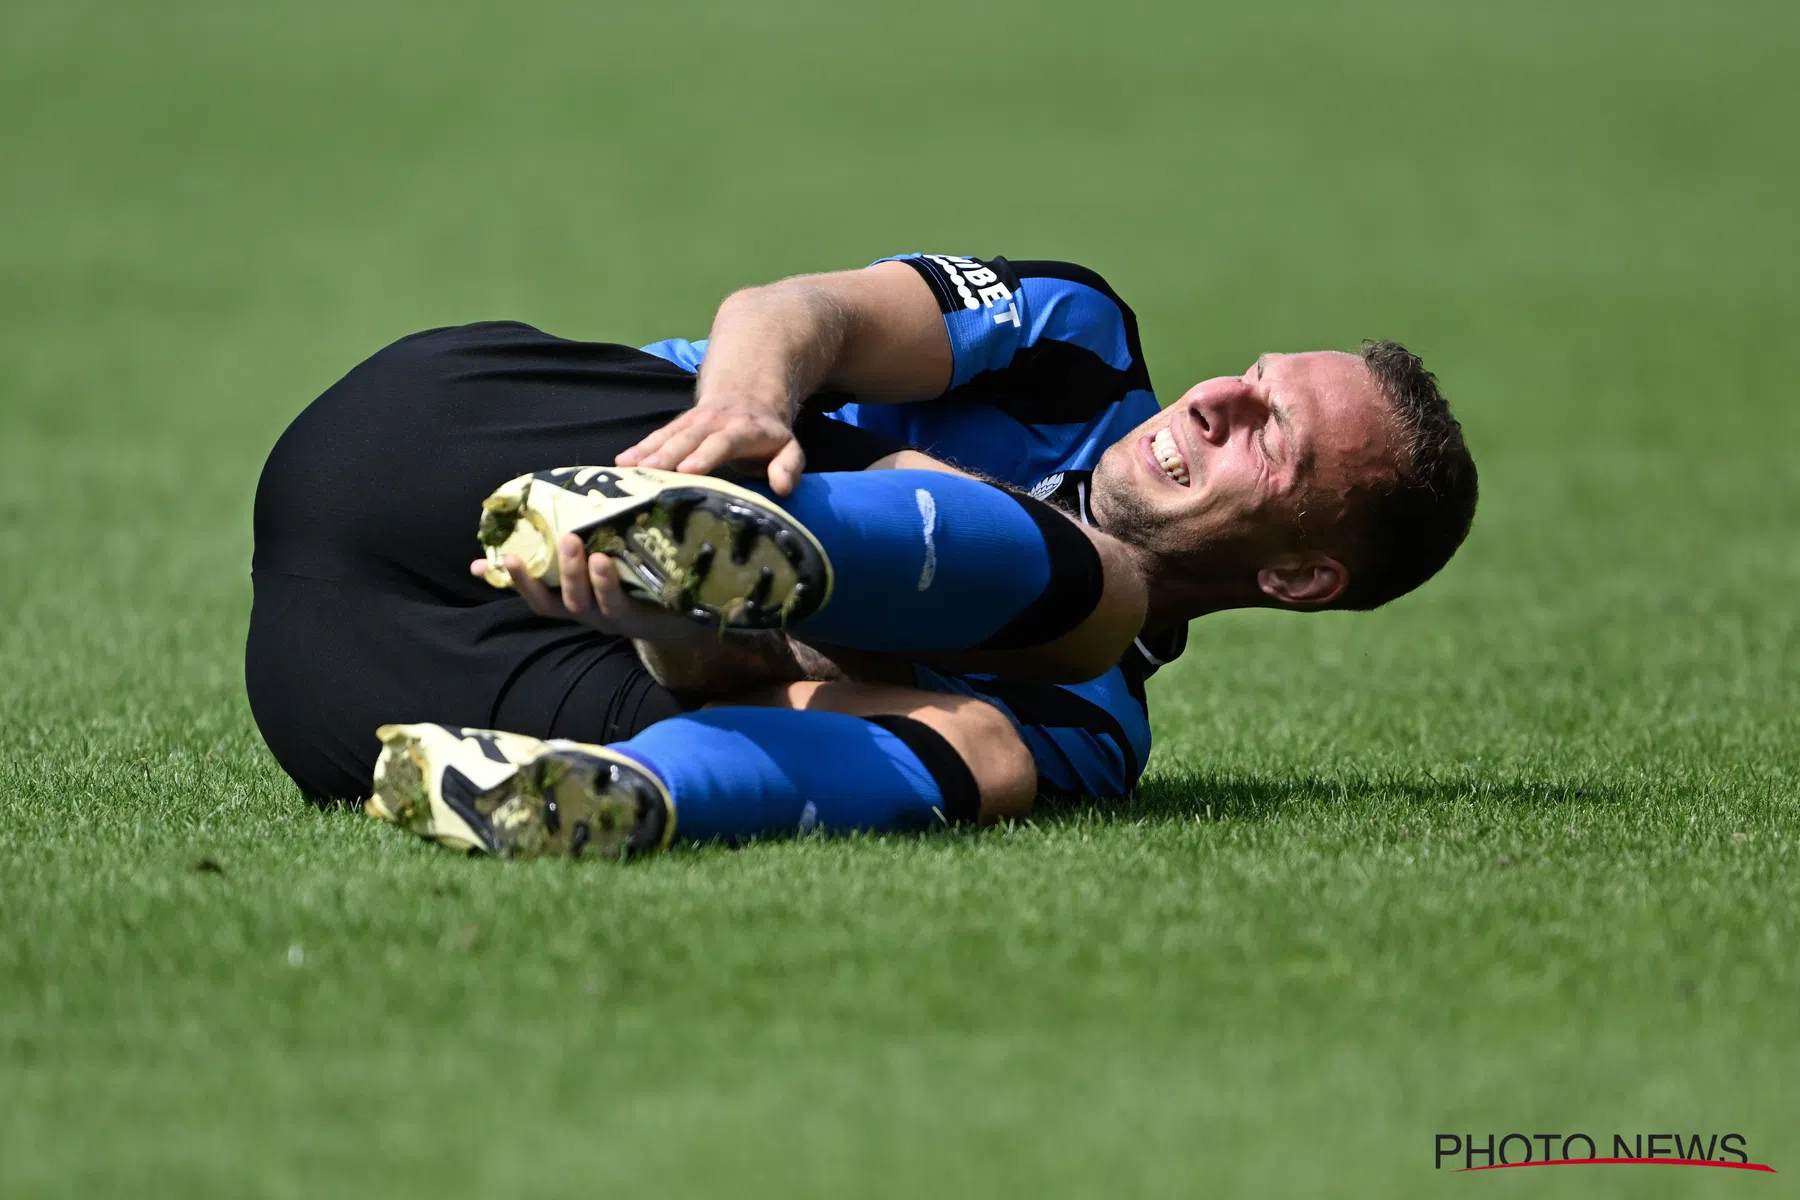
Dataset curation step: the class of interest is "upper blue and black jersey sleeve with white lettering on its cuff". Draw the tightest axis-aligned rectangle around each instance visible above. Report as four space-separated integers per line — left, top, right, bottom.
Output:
882 254 1154 425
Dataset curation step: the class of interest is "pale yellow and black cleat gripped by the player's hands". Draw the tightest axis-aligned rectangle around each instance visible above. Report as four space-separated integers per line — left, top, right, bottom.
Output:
477 466 832 630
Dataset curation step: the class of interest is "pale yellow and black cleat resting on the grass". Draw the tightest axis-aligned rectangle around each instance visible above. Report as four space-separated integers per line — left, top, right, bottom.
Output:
364 725 675 858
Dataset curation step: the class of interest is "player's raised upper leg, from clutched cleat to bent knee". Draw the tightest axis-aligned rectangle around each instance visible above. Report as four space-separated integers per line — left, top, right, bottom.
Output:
482 468 1145 680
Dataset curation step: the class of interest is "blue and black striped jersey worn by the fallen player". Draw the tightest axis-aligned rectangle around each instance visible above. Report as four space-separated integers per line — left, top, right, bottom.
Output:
644 254 1186 795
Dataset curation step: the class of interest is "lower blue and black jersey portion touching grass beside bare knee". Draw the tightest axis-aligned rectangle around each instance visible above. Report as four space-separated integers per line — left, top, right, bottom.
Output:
913 666 1150 797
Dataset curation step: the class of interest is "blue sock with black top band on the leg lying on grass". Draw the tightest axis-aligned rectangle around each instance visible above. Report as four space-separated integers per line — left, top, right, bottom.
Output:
612 709 979 842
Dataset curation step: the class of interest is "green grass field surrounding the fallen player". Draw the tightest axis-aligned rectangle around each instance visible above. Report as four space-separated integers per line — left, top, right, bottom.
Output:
0 0 1800 1196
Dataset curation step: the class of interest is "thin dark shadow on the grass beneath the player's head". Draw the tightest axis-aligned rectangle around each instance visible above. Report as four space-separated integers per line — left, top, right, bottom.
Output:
1031 770 1631 822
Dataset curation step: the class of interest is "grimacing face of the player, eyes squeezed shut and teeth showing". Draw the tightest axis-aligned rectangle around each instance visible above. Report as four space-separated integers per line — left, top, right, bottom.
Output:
1093 351 1399 558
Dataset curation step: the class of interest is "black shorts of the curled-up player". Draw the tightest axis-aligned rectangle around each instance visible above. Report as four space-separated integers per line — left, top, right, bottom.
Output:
245 322 900 801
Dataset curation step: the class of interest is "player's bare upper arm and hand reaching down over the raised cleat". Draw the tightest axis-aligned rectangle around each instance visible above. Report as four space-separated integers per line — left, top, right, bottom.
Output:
619 263 952 495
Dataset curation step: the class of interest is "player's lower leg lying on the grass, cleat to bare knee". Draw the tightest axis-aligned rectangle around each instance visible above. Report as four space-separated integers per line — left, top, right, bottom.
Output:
369 684 1037 856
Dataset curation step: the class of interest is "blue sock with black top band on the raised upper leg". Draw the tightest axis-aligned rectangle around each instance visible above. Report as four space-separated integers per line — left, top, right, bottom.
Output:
760 471 1102 653
